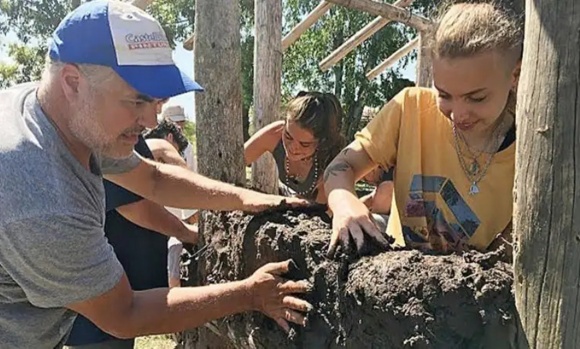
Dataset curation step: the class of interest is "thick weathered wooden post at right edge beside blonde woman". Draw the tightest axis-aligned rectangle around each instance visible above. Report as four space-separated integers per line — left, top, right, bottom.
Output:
514 0 580 349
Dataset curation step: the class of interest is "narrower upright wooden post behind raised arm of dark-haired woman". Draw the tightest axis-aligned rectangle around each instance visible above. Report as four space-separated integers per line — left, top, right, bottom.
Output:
252 0 282 194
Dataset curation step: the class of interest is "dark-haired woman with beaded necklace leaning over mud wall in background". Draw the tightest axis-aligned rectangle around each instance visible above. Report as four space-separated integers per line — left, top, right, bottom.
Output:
244 92 345 203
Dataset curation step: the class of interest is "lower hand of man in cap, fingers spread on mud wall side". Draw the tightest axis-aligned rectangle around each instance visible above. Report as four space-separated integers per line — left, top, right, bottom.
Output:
247 260 313 332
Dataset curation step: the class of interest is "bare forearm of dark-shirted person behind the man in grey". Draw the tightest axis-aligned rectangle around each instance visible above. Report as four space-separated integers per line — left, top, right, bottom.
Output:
117 199 188 239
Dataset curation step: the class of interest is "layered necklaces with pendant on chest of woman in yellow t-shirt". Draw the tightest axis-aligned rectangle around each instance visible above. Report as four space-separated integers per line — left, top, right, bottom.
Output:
453 110 513 195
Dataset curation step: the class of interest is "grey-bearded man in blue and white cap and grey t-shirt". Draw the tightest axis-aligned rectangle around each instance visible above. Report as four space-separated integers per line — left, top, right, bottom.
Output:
0 0 311 348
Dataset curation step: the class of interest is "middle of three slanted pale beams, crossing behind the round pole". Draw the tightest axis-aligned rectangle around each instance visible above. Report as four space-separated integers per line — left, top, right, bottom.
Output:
319 0 414 71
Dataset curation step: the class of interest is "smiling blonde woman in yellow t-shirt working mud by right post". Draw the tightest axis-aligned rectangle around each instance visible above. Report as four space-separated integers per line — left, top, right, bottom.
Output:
325 3 523 255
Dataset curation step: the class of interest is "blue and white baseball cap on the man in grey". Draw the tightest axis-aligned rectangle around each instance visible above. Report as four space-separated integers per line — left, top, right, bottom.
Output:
49 0 203 98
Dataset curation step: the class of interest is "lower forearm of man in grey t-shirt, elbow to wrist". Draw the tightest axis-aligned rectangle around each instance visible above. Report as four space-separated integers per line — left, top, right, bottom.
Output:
126 281 253 337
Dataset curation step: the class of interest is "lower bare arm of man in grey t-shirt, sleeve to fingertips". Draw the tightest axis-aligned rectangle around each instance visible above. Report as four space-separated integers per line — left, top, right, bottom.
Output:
67 261 312 338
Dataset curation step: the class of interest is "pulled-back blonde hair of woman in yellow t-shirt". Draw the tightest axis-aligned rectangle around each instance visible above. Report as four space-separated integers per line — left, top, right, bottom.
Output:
432 2 523 65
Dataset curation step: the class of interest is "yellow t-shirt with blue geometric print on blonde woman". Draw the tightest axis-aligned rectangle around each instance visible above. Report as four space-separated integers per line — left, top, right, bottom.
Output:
356 87 515 251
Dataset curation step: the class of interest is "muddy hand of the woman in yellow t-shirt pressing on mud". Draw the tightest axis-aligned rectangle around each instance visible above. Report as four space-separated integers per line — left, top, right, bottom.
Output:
327 196 390 258
